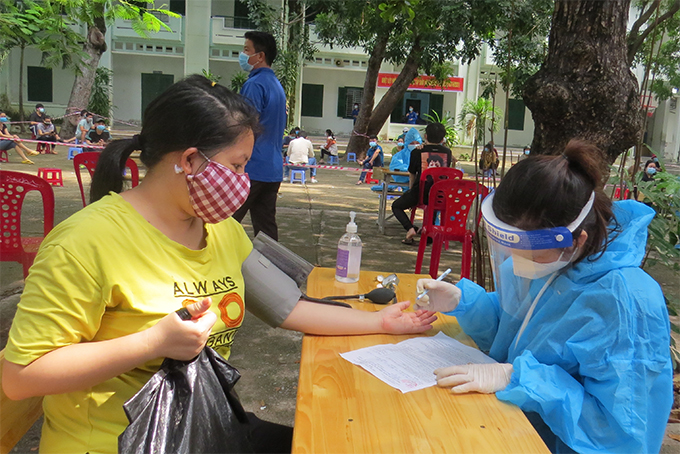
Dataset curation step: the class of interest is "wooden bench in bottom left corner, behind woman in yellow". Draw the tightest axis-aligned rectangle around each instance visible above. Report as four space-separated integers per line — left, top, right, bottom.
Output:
0 349 42 454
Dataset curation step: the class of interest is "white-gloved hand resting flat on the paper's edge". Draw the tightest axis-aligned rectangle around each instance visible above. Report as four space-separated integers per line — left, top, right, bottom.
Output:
434 363 513 394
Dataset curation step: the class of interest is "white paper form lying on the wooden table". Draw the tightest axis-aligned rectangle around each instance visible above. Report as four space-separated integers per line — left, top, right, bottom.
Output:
340 332 496 393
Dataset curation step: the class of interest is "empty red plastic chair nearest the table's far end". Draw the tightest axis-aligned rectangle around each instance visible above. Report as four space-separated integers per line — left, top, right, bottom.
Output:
416 179 489 279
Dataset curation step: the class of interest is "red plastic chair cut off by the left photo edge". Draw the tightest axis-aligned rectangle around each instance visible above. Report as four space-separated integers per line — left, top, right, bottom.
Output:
0 170 54 279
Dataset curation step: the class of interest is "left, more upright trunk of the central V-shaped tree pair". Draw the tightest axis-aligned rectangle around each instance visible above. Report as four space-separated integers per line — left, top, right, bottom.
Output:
347 33 390 159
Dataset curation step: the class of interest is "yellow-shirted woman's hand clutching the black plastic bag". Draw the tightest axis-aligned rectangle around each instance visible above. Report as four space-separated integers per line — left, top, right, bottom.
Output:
147 298 217 361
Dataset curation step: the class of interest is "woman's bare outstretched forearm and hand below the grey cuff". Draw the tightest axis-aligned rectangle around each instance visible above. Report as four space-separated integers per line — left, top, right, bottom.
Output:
281 299 437 335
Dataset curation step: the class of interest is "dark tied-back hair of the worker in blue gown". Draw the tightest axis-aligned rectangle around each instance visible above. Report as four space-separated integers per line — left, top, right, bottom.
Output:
493 140 614 261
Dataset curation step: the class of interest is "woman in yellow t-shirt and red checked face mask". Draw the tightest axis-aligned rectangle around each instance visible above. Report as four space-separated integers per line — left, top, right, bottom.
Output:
2 75 435 453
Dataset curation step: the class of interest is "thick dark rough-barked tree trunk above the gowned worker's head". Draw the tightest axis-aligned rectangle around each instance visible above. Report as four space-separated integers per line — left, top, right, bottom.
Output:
524 0 642 167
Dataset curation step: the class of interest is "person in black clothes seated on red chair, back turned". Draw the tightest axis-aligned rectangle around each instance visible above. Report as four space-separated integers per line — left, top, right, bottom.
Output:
392 123 456 244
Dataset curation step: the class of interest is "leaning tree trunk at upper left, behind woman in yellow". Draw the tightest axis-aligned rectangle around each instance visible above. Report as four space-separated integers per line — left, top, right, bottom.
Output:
60 13 106 138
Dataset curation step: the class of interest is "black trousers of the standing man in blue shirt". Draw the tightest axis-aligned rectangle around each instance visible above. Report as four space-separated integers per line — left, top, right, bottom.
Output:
233 180 281 241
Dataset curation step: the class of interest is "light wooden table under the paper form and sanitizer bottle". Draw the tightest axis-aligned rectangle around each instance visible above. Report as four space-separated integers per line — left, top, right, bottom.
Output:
292 268 550 454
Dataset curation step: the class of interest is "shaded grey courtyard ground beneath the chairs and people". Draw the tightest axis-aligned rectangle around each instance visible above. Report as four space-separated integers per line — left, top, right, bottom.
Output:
0 138 680 453
